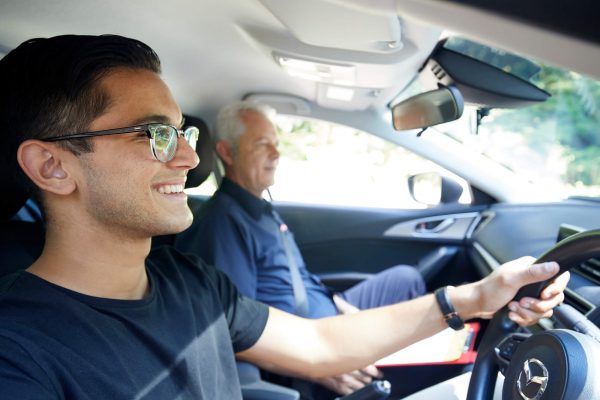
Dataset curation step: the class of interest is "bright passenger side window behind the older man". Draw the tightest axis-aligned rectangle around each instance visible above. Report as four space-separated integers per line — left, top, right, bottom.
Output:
270 115 471 208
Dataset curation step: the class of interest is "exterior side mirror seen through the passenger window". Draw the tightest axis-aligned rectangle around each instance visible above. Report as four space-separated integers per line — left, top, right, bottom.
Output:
408 172 463 207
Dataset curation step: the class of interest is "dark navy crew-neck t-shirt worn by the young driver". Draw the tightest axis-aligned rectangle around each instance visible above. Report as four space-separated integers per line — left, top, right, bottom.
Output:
0 247 268 400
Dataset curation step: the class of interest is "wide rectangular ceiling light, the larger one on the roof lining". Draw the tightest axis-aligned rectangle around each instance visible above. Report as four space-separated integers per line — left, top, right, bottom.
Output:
275 55 356 86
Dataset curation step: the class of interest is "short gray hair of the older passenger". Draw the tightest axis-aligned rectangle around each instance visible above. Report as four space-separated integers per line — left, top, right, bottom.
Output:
215 100 276 149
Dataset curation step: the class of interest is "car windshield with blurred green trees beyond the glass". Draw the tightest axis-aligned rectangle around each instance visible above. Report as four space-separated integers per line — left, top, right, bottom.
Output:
422 38 600 198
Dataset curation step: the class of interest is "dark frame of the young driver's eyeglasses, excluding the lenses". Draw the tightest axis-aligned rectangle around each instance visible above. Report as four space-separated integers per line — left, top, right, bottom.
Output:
40 123 200 162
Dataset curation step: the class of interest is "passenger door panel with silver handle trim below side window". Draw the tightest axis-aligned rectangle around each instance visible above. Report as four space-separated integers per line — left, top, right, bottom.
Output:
274 202 484 283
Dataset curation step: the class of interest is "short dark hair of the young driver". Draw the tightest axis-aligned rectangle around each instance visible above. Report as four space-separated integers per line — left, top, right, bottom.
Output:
0 35 160 205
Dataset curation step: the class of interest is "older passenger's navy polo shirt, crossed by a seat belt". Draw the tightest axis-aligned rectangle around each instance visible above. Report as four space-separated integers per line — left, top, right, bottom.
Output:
175 178 337 318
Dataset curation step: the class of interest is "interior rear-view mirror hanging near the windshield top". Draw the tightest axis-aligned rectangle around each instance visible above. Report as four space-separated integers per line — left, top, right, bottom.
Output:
392 86 464 131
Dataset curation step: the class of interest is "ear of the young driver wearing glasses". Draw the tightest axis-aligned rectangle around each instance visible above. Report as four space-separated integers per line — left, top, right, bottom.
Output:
17 140 77 195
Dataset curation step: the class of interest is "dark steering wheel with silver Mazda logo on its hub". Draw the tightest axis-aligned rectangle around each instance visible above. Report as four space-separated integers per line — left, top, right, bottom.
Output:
467 230 600 400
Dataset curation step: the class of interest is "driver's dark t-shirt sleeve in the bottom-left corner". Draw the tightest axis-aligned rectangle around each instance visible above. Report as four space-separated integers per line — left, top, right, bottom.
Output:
0 336 58 400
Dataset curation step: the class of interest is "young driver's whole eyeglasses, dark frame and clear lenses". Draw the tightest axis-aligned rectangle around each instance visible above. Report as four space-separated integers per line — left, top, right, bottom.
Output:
42 124 200 162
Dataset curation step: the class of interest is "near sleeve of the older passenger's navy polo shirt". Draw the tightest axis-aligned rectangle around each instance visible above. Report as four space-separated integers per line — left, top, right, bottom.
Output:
175 208 257 299
